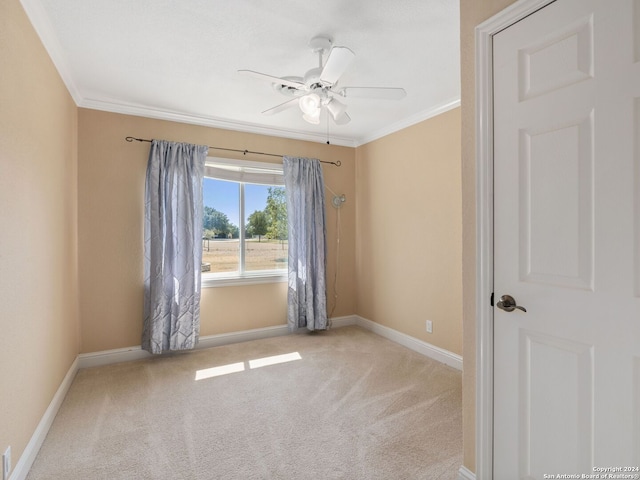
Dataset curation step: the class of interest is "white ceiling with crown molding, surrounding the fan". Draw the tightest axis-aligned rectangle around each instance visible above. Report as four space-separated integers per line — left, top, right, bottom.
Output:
22 0 460 146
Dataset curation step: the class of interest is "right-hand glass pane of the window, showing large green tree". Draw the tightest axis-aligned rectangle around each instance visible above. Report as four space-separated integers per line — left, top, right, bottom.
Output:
244 184 288 272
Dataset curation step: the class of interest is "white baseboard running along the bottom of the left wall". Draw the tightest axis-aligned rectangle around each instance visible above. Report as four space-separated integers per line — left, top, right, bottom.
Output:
9 357 78 480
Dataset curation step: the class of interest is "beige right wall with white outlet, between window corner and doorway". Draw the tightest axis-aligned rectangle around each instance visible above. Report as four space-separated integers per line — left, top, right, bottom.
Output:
356 108 462 354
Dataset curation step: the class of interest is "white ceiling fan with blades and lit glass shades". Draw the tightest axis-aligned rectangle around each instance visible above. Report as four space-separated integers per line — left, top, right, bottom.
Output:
238 35 406 125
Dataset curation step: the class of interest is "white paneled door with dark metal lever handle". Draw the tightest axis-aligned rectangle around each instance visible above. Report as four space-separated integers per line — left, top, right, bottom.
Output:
493 0 640 480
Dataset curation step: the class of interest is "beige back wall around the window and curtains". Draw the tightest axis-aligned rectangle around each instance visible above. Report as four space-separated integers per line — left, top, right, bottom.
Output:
78 109 356 352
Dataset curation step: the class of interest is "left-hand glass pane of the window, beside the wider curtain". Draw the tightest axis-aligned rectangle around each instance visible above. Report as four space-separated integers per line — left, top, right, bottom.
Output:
202 178 240 273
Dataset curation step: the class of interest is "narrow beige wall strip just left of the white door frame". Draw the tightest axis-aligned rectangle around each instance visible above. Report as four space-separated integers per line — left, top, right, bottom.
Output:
460 0 514 471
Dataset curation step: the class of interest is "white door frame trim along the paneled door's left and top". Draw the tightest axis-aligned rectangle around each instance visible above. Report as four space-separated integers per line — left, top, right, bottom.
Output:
475 0 556 480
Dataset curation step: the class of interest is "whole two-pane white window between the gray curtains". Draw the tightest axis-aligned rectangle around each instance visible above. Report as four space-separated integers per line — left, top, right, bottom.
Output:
202 157 288 287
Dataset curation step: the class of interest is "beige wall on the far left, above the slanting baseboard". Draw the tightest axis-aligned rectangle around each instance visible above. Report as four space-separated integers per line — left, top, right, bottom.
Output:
0 0 79 467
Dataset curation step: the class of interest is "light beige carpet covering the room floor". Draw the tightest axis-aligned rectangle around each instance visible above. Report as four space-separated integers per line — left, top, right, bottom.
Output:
27 327 462 480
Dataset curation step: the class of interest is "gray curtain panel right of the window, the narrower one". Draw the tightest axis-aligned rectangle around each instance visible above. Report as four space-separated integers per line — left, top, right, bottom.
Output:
283 157 327 331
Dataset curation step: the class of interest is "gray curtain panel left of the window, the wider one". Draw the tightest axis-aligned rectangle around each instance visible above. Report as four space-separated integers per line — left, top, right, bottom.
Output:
142 140 209 353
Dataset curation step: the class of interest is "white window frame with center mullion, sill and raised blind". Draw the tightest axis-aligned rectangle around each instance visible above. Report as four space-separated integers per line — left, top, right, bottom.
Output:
201 157 287 288
